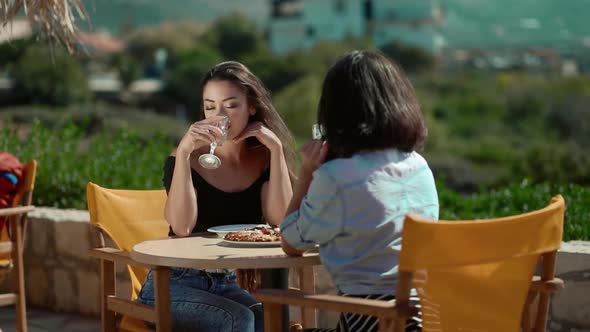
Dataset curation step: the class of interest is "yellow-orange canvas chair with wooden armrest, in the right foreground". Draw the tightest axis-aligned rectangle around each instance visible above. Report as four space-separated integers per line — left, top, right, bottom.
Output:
256 196 565 332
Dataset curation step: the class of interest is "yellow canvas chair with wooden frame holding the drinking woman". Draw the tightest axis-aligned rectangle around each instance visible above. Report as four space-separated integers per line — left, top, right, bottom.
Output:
86 182 171 331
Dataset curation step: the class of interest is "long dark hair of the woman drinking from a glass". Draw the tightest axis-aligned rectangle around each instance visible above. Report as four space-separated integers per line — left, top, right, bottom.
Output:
199 61 295 171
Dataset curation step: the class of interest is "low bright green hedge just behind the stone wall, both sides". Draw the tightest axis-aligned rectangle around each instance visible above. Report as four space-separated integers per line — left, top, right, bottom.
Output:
0 122 590 240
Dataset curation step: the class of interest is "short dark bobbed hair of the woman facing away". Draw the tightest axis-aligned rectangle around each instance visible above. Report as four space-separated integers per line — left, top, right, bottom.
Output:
318 51 428 160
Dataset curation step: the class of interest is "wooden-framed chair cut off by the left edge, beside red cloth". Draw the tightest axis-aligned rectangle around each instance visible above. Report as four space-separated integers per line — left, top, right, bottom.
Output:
0 160 37 332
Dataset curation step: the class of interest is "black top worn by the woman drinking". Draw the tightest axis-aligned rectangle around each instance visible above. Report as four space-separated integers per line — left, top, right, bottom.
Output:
162 156 270 236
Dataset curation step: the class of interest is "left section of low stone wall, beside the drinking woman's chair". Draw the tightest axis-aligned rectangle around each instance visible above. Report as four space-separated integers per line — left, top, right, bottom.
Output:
1 207 130 316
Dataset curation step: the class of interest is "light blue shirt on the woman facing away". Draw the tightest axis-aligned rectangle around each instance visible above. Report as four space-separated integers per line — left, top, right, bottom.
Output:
281 150 439 295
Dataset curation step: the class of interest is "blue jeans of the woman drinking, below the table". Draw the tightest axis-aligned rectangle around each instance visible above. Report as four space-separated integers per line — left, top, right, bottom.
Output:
137 268 264 332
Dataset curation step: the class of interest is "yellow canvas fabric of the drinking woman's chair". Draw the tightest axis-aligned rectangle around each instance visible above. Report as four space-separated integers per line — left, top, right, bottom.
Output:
86 182 168 300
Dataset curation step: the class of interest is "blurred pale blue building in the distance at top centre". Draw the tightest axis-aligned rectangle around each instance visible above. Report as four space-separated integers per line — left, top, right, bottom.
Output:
269 0 445 54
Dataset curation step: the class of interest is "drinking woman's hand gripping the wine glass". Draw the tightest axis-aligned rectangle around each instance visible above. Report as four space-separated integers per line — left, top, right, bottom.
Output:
177 116 226 157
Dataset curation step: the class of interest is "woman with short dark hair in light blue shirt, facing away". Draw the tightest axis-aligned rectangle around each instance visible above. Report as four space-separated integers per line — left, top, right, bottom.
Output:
281 51 439 332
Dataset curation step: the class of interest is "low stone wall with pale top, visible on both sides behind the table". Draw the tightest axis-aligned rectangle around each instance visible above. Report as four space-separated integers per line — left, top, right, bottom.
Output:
1 208 590 332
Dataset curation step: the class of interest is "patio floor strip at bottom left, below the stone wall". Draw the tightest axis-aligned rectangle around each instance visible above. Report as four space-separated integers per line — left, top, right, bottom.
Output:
0 306 100 332
